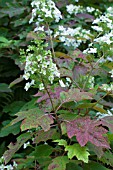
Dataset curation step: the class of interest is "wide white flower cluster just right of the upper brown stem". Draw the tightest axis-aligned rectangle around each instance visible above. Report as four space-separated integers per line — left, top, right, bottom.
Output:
54 25 91 48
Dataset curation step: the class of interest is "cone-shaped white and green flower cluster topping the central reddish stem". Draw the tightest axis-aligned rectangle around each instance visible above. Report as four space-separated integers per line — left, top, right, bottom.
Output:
23 41 60 91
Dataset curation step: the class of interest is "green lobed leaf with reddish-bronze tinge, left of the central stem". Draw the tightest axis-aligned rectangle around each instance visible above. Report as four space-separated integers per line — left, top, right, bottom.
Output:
11 108 54 131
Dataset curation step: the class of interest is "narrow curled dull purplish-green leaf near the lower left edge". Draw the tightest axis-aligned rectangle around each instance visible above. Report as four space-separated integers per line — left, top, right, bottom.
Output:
3 132 32 164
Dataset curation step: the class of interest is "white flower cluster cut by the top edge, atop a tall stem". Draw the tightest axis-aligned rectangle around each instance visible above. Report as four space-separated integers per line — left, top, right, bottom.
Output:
29 0 62 28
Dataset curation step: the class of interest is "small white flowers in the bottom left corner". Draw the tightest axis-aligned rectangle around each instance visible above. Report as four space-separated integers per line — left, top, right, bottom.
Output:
0 156 17 170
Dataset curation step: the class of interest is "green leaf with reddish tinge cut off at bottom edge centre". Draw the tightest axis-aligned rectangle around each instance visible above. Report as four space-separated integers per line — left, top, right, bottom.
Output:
48 156 69 170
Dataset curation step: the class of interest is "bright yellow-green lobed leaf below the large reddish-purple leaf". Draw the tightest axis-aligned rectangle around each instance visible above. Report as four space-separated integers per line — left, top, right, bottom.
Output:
65 144 90 163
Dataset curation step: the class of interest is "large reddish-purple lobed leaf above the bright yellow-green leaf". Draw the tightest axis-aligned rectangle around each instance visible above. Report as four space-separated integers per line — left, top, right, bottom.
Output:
66 117 110 148
